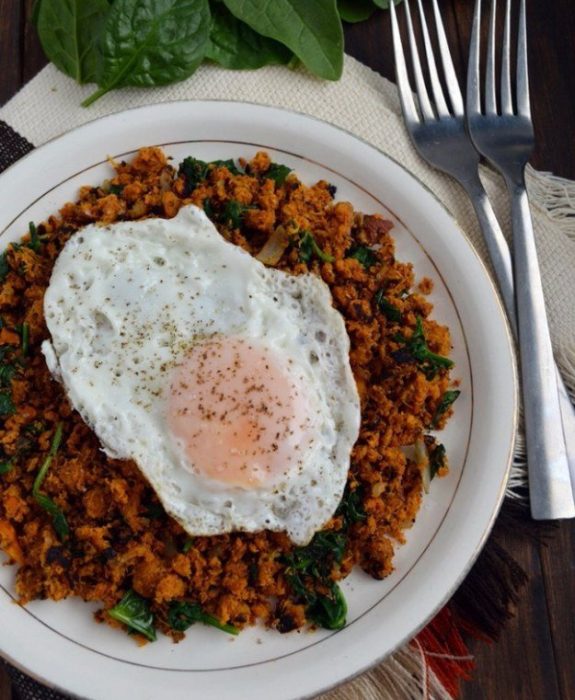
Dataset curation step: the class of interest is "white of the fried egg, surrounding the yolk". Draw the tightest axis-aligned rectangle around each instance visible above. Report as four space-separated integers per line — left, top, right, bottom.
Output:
42 205 360 545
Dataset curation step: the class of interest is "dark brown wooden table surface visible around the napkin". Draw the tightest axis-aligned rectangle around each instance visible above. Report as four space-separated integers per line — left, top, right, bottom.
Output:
0 0 575 700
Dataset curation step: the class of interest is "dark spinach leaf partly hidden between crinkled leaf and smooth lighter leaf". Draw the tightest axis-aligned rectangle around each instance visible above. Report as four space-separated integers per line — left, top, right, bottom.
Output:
206 3 292 70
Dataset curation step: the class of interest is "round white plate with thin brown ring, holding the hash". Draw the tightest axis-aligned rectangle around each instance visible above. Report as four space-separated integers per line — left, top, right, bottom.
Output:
0 102 517 700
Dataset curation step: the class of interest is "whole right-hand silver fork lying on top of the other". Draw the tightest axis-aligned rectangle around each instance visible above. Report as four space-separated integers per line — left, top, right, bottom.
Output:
467 0 575 519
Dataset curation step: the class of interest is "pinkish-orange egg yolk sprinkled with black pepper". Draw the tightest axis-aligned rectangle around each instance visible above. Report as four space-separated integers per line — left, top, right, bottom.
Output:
168 336 312 488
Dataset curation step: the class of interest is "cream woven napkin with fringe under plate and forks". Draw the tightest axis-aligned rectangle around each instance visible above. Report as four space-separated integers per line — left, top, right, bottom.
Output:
0 57 575 700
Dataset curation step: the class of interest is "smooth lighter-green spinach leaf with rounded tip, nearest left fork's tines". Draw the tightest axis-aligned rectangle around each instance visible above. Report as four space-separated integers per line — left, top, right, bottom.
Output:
224 0 343 80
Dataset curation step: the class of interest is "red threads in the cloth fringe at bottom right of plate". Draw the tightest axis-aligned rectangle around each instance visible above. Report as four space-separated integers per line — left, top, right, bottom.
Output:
412 607 475 698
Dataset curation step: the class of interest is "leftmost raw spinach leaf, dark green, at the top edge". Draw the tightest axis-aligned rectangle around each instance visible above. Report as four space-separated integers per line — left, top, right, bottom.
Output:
34 0 110 83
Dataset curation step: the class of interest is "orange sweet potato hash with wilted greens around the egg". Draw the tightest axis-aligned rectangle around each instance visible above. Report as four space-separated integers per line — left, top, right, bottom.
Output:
0 148 459 641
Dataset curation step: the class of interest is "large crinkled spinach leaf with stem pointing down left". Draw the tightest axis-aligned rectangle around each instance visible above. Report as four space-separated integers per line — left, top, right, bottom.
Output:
83 0 211 107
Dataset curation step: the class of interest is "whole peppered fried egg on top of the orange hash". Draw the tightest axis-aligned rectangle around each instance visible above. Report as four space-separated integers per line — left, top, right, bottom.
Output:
42 205 360 545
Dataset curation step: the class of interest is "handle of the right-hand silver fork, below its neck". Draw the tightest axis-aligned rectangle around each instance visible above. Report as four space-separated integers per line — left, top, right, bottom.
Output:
507 176 575 520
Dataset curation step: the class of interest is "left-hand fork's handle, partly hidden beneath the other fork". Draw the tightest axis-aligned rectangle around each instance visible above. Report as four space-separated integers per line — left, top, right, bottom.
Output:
461 174 575 512
